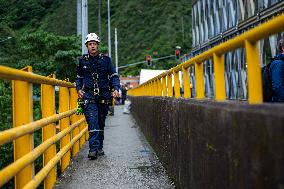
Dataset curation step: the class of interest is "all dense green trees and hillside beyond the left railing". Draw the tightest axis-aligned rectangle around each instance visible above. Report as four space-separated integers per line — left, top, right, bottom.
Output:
0 0 191 187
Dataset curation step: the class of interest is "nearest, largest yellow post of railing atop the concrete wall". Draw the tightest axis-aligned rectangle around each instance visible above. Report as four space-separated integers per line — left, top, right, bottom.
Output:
245 40 263 104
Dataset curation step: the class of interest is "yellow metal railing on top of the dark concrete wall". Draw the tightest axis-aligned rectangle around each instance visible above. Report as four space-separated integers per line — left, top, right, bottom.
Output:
128 14 284 104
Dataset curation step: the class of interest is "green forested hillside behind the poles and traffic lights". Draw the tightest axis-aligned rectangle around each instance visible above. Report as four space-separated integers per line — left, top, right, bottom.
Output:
0 0 191 74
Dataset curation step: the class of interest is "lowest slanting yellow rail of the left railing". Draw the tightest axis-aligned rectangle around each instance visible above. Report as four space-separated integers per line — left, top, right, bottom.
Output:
23 128 87 189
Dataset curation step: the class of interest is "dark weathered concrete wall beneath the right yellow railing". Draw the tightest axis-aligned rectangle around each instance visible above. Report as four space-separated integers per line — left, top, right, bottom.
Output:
131 97 284 189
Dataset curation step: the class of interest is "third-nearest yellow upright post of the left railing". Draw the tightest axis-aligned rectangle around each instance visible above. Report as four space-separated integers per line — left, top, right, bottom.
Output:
59 87 70 172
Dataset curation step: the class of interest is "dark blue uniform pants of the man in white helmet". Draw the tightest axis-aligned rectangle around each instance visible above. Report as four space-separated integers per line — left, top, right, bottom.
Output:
84 103 108 152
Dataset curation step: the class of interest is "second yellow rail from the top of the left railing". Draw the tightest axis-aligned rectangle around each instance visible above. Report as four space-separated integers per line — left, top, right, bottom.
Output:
0 109 76 145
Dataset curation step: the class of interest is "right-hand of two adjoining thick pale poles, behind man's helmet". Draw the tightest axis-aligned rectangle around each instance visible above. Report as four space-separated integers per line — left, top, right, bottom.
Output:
82 0 88 54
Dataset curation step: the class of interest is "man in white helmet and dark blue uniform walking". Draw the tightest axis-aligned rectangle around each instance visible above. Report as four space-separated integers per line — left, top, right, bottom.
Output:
76 33 120 159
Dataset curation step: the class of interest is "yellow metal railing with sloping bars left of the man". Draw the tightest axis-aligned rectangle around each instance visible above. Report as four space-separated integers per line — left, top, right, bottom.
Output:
0 66 88 189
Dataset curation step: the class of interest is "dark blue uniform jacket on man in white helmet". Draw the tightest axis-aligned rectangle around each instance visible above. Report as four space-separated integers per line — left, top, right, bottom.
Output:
76 54 120 99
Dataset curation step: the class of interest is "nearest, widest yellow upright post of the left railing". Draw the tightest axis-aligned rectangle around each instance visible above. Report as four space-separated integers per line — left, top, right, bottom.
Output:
12 66 34 189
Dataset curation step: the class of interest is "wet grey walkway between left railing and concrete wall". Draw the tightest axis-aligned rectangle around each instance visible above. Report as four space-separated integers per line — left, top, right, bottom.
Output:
52 106 175 189
